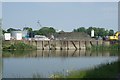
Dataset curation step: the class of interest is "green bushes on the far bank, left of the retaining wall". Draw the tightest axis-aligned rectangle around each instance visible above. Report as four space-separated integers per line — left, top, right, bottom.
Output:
3 42 36 50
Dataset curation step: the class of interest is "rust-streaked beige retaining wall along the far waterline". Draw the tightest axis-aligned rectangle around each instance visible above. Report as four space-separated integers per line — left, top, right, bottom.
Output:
25 40 110 50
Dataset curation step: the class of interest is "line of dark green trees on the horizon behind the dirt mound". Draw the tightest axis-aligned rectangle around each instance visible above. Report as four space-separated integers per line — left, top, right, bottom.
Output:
2 27 114 37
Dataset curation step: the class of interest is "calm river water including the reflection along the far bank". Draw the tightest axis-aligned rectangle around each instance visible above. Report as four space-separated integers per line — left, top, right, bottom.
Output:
3 50 118 78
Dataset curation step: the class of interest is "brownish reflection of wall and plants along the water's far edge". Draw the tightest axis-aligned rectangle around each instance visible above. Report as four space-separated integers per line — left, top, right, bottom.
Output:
3 50 118 57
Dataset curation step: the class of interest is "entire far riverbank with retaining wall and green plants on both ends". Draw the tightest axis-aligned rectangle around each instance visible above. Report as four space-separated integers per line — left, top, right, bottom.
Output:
2 40 120 50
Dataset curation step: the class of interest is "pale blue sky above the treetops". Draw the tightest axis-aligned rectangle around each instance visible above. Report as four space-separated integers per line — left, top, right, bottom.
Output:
2 2 118 32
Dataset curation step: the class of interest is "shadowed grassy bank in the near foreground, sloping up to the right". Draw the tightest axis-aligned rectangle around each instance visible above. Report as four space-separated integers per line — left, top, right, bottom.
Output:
53 61 120 79
